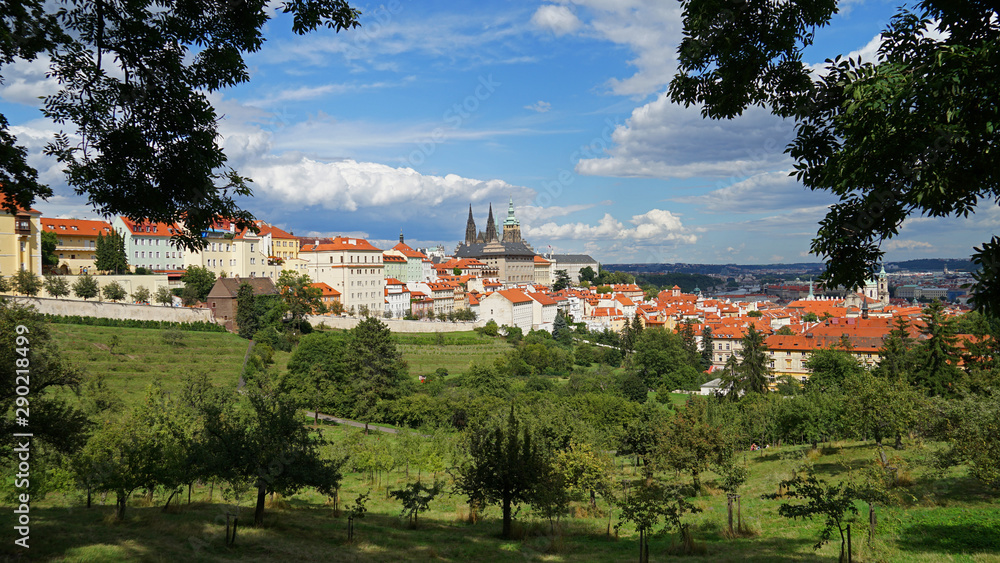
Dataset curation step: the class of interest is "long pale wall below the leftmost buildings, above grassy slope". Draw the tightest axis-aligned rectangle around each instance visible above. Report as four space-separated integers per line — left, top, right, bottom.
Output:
7 297 213 323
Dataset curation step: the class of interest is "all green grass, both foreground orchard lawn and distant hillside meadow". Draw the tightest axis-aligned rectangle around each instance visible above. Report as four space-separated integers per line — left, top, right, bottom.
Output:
17 325 1000 563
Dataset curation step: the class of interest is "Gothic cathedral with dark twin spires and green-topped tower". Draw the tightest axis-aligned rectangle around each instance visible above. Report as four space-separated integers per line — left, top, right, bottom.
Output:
455 198 536 283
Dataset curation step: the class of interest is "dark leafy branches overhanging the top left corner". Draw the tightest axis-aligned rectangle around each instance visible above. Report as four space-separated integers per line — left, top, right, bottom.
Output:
0 0 360 249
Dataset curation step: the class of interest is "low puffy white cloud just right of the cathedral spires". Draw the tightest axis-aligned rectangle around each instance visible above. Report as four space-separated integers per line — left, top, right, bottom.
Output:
526 209 698 244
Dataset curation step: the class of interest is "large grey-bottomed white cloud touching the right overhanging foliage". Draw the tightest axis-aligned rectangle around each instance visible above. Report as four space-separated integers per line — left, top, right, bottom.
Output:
576 96 793 178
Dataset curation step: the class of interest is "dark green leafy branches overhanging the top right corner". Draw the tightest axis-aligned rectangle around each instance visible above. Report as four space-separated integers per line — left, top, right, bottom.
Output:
670 0 1000 313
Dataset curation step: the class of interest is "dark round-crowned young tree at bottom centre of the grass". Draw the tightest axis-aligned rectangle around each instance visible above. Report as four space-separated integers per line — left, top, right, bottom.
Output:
455 405 547 539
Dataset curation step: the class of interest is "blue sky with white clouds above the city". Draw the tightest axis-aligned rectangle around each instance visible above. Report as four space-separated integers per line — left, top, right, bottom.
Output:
0 0 1000 264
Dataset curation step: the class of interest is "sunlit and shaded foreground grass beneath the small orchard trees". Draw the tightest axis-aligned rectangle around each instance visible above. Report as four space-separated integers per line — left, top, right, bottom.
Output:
9 427 1000 562
